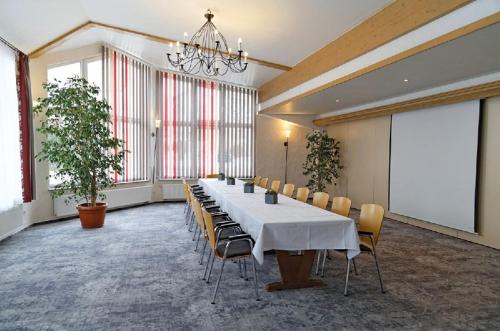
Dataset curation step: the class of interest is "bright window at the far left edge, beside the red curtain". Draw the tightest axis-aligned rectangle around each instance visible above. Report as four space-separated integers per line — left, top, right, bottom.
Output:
0 42 23 212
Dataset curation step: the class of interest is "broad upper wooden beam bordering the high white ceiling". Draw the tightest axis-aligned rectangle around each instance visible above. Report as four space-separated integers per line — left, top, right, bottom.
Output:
259 0 471 102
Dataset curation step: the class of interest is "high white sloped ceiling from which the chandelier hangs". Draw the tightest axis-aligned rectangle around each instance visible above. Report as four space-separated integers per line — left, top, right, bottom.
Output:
0 0 392 86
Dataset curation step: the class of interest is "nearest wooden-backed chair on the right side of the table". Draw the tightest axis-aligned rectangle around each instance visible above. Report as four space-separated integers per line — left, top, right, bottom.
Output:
344 204 385 295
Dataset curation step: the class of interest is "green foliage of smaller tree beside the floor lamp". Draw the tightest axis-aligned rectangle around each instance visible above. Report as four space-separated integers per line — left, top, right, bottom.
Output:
302 131 342 192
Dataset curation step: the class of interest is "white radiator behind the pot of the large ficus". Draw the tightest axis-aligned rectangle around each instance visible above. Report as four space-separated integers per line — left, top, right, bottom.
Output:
54 186 153 217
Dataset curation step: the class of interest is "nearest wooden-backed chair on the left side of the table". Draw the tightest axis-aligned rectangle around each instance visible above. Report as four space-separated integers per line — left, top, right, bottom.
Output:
202 209 260 304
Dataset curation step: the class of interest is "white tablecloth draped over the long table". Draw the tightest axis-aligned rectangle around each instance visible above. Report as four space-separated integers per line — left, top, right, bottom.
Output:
199 179 360 264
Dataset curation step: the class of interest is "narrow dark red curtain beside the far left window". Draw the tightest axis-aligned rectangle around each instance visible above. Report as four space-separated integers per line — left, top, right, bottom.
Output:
16 51 35 202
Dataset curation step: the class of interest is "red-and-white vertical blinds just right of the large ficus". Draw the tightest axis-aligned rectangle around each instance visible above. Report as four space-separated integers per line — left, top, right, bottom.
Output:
103 47 148 183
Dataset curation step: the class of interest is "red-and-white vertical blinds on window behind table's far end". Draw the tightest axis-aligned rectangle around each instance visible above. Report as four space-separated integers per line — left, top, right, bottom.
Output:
156 71 257 179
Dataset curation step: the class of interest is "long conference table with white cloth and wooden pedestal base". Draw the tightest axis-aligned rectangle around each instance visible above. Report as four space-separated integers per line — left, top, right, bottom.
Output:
199 178 360 291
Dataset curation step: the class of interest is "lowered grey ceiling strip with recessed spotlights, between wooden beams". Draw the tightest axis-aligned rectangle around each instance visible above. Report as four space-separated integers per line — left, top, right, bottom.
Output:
264 23 500 117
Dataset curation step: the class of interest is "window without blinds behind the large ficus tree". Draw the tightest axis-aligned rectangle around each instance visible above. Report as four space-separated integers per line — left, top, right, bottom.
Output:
47 57 102 187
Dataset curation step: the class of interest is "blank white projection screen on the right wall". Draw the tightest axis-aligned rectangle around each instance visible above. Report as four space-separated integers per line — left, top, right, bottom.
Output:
389 100 480 232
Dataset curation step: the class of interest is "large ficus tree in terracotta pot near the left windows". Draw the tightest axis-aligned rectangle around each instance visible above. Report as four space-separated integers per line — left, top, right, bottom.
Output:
33 77 125 228
